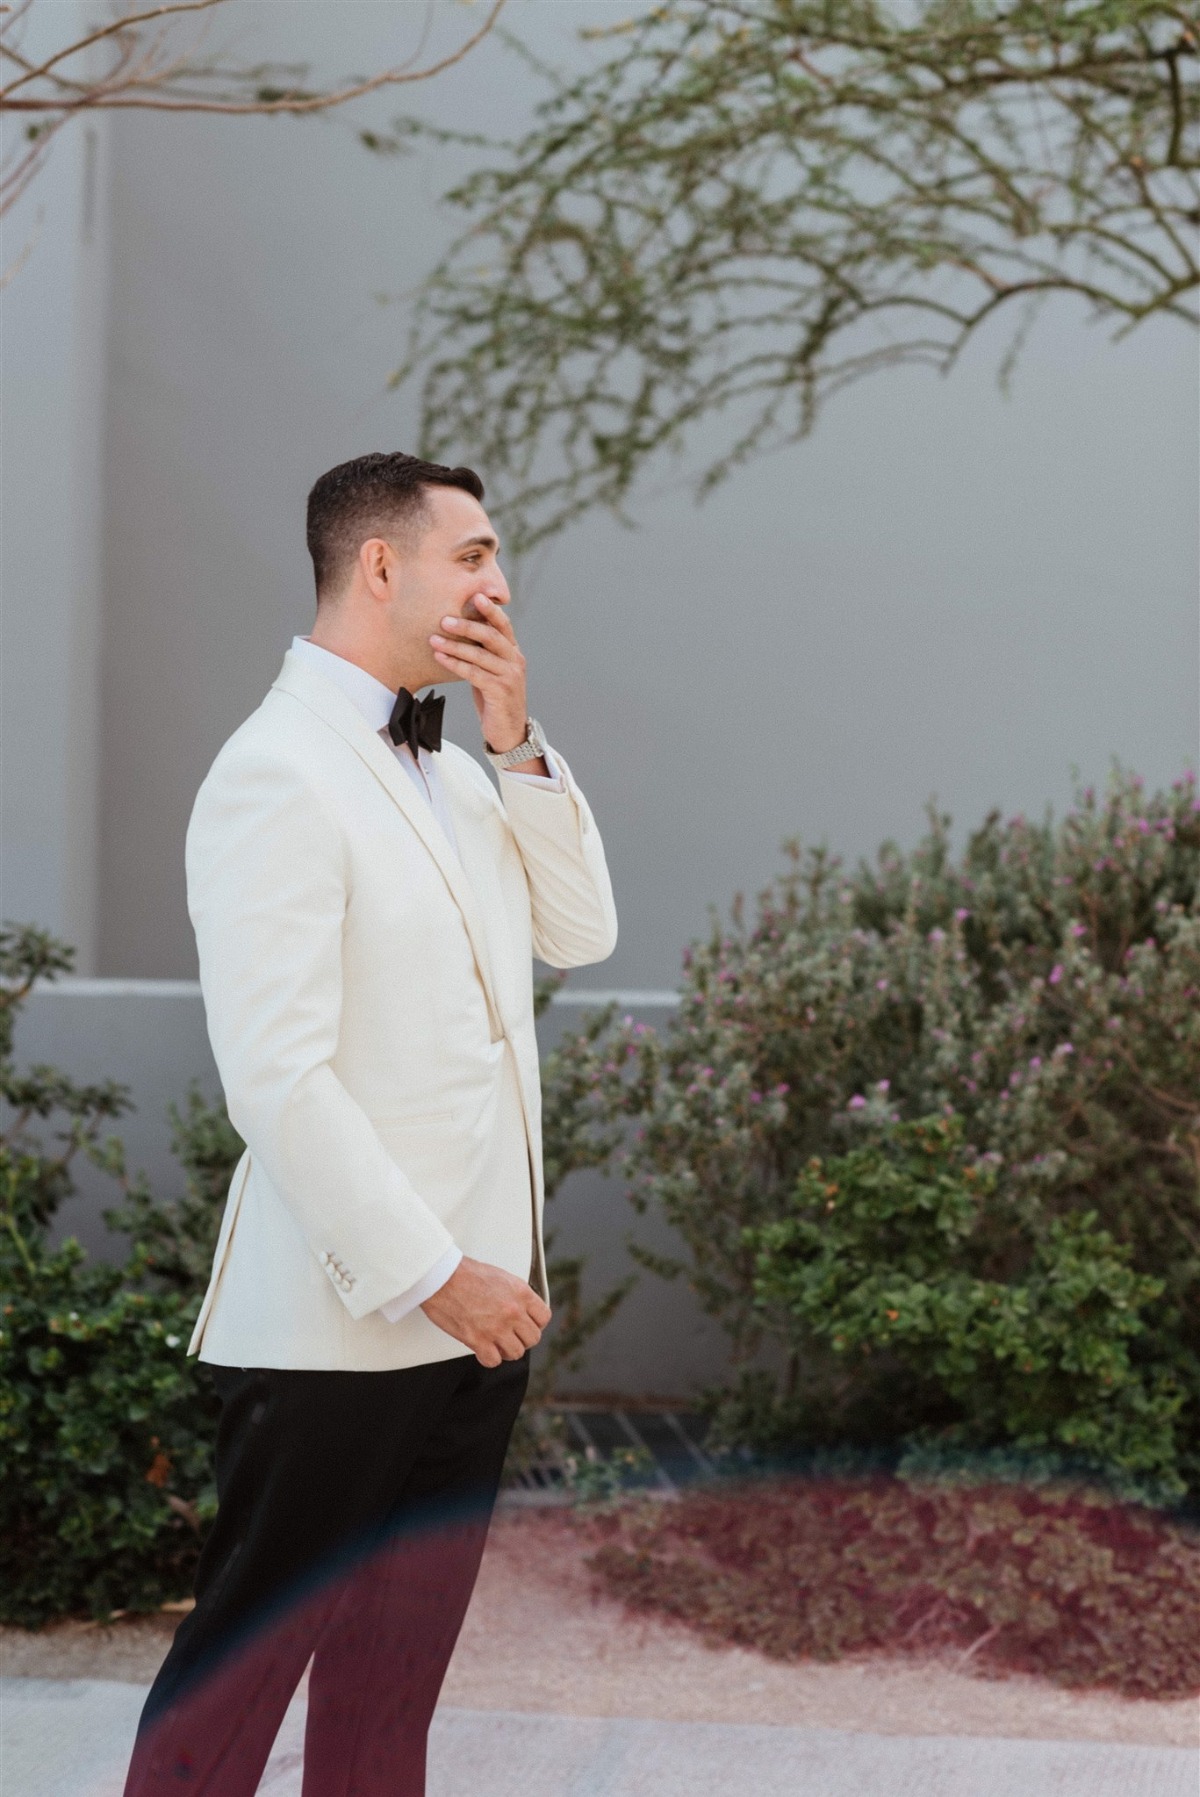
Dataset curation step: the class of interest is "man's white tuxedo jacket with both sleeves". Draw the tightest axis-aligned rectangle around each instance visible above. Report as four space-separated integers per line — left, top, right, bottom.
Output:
187 652 616 1371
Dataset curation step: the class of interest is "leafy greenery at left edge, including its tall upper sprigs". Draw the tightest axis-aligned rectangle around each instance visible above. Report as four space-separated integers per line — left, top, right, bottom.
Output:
0 929 227 1626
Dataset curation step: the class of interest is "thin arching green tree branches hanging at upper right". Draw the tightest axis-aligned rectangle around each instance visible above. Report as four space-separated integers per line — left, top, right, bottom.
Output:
391 0 1200 543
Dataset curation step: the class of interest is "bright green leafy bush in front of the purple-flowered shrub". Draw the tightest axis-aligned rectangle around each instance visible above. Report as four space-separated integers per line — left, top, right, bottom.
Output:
751 1118 1184 1495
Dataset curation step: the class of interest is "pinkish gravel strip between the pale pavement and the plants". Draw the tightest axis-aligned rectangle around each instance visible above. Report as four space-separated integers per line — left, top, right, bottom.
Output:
0 1509 1200 1747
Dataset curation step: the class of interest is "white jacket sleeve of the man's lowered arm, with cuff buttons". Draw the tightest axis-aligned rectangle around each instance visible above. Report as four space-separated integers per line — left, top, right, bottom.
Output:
187 751 454 1319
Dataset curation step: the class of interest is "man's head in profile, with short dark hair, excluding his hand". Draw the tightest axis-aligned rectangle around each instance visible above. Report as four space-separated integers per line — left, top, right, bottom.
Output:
307 451 508 692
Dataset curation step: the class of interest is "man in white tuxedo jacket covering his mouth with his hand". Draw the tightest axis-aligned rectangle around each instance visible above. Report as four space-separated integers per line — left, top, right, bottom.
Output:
126 455 616 1797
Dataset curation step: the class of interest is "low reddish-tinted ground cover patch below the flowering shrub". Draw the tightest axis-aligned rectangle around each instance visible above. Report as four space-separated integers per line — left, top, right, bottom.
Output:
589 1479 1200 1698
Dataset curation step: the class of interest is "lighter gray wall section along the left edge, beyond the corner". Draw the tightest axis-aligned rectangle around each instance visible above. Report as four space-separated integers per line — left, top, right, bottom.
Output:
0 0 110 970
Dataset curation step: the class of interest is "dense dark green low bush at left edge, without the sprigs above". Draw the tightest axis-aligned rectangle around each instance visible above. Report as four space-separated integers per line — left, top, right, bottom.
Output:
0 1243 216 1626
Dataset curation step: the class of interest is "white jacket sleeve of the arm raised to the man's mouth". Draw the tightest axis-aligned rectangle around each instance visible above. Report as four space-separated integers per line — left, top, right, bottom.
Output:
499 749 616 967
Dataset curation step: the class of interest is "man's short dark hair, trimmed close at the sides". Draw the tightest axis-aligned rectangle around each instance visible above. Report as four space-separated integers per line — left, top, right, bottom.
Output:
307 449 483 602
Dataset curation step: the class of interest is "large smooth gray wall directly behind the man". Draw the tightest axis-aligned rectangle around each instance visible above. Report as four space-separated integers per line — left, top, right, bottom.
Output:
79 0 1198 985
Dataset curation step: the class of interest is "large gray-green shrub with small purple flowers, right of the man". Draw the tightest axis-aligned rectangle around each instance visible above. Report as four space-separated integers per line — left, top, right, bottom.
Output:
546 771 1200 1492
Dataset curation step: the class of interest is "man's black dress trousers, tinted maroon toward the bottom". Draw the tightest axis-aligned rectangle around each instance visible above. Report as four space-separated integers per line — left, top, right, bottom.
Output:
126 1355 528 1797
